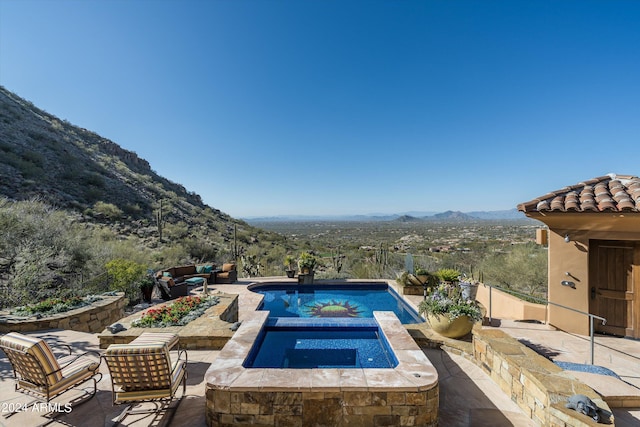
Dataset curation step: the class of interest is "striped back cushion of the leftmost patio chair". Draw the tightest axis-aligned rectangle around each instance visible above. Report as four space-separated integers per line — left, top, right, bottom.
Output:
0 332 62 386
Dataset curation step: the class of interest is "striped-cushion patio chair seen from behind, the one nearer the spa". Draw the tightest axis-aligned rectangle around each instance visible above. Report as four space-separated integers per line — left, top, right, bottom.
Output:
102 341 187 425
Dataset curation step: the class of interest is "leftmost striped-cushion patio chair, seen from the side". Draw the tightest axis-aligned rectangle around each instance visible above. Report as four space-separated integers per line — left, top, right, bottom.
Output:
0 332 102 417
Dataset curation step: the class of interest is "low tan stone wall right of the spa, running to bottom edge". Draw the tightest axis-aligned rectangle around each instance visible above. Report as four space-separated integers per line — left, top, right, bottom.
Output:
473 329 613 427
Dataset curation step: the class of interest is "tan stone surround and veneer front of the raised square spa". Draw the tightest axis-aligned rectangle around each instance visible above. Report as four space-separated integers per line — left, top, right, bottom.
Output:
205 311 439 427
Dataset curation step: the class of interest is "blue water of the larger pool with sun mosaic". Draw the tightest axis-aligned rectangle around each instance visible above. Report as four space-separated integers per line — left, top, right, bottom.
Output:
251 283 422 324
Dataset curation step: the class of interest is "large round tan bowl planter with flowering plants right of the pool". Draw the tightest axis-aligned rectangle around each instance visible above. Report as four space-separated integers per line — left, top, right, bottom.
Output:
418 284 483 338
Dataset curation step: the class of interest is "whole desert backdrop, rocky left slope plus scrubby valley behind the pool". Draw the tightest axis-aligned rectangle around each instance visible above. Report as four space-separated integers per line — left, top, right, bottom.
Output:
0 87 547 307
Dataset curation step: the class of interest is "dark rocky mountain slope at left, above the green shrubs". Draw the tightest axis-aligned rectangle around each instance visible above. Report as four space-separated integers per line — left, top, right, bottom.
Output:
0 86 279 254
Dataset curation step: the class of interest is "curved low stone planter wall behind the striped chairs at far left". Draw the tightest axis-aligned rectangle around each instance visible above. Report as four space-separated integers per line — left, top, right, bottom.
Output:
0 292 127 333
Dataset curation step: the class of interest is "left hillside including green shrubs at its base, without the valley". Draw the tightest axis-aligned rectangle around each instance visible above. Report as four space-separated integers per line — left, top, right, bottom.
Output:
0 87 287 305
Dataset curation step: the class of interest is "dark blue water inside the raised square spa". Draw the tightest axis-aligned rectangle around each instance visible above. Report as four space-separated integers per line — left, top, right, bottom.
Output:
244 319 398 369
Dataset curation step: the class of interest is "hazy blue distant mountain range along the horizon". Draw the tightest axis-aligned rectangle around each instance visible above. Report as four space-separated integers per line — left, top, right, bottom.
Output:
243 208 528 224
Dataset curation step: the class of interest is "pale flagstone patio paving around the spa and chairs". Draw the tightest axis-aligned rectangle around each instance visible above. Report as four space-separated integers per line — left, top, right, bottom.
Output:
0 278 640 427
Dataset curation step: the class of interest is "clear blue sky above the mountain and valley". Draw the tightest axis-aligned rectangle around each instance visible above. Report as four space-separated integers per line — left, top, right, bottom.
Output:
0 0 640 217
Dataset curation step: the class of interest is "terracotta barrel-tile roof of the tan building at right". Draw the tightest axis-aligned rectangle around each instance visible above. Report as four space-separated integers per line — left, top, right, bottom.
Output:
518 174 640 214
